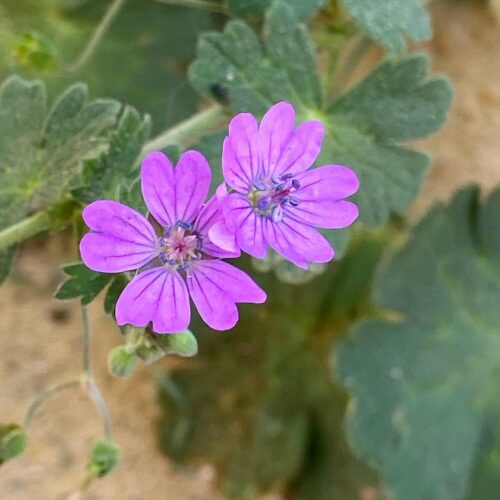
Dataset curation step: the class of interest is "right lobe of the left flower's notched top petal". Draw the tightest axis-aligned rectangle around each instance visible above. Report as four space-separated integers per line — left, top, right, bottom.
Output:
174 151 212 223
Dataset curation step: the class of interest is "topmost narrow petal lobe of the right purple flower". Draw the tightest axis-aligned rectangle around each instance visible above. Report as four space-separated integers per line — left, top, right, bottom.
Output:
259 102 295 177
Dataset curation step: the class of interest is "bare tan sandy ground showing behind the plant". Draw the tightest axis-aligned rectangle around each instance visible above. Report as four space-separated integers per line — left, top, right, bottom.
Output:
0 2 500 500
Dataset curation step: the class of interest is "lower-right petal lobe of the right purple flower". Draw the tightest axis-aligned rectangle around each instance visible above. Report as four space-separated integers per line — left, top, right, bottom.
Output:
265 218 334 269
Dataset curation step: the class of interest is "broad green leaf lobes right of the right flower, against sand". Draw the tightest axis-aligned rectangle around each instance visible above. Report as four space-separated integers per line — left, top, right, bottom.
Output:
328 55 452 225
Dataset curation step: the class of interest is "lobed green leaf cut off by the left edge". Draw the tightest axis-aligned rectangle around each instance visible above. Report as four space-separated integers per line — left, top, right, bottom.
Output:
0 76 120 228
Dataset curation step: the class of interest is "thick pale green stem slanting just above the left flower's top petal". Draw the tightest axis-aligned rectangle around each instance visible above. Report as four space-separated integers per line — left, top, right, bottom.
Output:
141 105 225 157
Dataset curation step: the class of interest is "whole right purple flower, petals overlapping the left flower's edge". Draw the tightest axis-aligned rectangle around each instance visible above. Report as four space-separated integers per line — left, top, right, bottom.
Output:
215 102 359 269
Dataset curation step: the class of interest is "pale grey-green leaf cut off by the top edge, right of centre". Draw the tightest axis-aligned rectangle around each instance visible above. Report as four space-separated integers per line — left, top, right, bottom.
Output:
341 0 432 52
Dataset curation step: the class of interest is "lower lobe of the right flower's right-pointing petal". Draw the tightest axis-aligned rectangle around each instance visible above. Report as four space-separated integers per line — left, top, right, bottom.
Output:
285 200 359 229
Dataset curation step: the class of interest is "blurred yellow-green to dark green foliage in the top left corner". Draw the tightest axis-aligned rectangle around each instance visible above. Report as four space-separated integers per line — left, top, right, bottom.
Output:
0 0 223 132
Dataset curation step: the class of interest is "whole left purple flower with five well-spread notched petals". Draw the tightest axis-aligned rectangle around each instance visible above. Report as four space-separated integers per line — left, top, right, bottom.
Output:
80 151 266 333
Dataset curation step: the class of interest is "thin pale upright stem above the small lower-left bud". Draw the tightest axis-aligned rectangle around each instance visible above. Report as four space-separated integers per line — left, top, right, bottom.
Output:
81 305 113 441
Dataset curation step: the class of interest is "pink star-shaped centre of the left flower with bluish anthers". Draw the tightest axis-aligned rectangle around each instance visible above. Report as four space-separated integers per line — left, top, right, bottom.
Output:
158 221 203 271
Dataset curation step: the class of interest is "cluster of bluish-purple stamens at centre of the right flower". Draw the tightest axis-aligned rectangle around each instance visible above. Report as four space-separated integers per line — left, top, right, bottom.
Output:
248 174 300 222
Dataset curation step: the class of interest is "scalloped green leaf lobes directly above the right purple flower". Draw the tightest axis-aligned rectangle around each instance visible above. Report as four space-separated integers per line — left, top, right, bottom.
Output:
189 3 320 114
